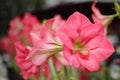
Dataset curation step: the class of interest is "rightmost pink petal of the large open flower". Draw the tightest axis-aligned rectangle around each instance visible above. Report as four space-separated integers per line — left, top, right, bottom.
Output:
90 37 114 61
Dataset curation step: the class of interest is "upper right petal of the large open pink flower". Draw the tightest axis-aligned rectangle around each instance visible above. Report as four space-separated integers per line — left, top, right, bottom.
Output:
79 23 104 44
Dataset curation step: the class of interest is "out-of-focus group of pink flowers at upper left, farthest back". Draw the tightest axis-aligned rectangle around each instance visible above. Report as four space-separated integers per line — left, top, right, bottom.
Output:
0 13 41 56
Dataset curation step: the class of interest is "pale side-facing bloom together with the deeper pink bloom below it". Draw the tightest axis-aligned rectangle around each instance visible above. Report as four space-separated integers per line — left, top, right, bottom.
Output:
15 15 68 79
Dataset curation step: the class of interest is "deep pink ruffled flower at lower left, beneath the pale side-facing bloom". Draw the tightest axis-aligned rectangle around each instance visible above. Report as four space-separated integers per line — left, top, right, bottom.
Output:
15 41 52 80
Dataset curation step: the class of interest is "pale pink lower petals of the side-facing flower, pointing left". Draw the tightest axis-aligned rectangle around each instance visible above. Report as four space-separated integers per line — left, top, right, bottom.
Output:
26 40 56 65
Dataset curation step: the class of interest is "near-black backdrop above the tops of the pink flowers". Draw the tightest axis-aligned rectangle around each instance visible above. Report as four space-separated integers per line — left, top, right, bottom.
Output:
0 0 120 37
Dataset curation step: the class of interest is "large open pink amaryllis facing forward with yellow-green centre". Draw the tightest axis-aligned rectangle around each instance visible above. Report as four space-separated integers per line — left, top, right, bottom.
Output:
58 12 114 71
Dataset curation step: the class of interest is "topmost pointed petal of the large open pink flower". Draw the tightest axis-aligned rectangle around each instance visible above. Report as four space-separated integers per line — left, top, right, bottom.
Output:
65 11 91 30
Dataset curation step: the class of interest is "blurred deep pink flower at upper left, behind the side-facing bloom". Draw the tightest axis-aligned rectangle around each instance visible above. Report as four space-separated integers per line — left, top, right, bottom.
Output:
22 13 41 44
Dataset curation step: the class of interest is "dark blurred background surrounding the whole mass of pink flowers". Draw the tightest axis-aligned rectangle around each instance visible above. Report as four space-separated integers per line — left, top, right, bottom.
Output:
0 0 120 80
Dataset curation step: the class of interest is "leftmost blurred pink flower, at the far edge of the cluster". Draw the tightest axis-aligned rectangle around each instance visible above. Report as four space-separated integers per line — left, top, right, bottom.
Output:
0 17 23 56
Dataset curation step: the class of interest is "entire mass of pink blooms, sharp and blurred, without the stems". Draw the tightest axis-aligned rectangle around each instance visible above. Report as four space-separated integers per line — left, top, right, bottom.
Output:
2 3 114 80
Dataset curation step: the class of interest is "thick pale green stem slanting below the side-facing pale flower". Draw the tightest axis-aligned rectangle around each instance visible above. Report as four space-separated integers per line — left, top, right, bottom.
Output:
48 58 59 80
